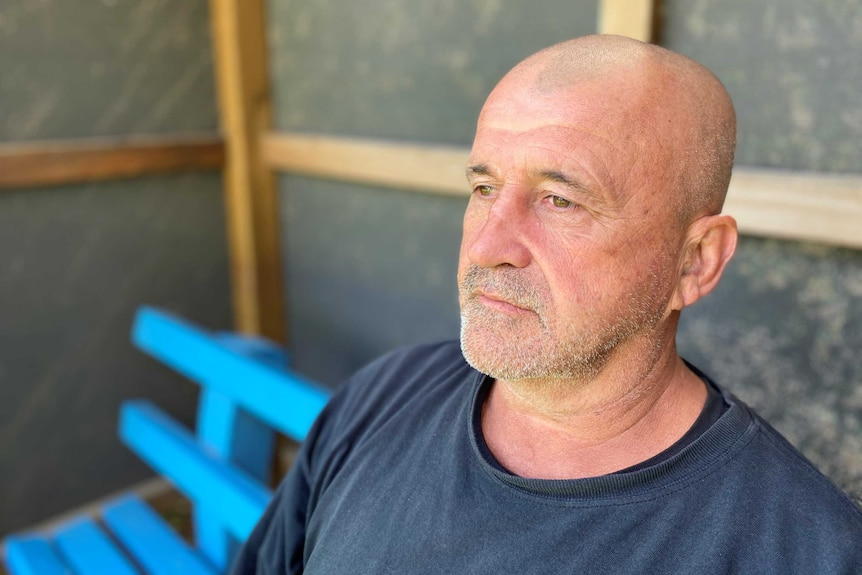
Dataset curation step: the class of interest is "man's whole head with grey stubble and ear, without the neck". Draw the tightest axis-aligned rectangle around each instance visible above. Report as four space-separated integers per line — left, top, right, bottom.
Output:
458 36 736 388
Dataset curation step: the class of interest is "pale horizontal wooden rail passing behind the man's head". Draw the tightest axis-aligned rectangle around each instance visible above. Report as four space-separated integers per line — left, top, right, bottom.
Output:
262 133 862 248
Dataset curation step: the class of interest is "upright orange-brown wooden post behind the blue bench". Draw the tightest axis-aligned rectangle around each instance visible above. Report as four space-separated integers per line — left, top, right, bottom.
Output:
210 0 286 342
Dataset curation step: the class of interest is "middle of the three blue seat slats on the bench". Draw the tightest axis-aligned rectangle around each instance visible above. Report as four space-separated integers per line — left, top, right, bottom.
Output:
54 517 140 575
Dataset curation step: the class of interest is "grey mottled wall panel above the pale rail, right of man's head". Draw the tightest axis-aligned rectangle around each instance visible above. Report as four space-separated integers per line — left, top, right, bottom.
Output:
661 0 862 172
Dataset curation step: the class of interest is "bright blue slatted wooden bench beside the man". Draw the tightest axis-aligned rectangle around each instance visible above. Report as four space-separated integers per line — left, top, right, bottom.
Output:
4 307 329 575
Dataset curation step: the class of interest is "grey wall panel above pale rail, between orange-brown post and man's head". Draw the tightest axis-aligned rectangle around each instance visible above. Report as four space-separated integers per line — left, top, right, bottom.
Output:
269 0 597 144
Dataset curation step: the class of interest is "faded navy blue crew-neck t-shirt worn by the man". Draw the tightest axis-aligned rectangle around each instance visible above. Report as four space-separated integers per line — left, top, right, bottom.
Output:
233 342 862 575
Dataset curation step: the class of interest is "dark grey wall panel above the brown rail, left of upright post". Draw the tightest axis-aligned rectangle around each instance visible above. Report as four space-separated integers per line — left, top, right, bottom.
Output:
0 0 217 140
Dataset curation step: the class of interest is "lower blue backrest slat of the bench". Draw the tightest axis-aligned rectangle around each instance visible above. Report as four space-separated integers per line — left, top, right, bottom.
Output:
120 400 272 540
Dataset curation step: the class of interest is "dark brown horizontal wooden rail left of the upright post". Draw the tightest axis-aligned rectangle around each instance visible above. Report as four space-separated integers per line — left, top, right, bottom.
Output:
0 135 224 190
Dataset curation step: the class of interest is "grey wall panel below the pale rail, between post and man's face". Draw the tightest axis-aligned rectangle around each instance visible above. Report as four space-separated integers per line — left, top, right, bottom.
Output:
281 177 467 385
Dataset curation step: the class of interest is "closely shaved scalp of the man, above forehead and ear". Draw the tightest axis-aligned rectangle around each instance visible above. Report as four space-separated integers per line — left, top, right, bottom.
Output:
480 35 736 223
